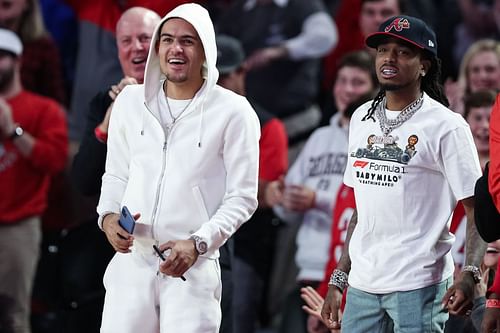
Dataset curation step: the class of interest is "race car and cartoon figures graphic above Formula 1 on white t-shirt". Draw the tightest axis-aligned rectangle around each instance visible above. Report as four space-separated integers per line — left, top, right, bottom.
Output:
351 134 418 164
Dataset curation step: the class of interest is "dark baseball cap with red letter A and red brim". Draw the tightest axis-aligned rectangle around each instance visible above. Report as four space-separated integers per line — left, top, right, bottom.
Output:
366 15 437 56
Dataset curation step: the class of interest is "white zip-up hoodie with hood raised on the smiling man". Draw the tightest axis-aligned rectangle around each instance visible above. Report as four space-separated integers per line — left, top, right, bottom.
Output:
97 4 260 258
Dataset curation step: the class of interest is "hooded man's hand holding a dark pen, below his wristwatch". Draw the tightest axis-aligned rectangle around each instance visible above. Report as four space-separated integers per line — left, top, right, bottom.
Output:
160 239 198 277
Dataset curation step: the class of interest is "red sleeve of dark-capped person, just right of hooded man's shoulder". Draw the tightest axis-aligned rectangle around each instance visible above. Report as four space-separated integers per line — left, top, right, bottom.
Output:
259 118 288 181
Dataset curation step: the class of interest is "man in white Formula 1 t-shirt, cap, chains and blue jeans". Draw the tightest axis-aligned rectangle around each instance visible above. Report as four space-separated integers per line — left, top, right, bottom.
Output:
322 15 485 333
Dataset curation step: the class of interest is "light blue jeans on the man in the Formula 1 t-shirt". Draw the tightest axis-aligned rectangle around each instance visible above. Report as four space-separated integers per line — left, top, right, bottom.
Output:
342 278 452 333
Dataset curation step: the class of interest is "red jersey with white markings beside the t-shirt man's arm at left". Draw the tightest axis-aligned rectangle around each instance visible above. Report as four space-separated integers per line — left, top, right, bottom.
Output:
318 184 356 297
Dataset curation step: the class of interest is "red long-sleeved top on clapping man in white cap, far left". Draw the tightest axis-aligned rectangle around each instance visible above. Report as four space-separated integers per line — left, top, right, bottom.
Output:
0 91 68 224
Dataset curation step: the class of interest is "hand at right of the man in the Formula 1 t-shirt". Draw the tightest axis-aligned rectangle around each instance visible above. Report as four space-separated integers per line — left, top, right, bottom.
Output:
442 272 476 316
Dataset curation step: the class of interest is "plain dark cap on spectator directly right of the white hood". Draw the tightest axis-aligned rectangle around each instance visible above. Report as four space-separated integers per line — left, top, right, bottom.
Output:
215 35 245 75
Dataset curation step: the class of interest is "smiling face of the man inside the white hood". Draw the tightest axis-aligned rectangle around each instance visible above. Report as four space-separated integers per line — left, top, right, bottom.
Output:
157 18 205 84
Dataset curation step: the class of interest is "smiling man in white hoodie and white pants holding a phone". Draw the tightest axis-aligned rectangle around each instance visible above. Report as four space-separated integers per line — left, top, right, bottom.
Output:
97 4 260 333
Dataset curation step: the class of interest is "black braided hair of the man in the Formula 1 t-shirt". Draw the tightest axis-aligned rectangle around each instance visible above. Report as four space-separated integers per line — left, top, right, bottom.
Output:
361 51 450 121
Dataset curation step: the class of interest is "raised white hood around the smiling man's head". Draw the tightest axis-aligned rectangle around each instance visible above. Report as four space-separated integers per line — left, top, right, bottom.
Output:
144 3 219 101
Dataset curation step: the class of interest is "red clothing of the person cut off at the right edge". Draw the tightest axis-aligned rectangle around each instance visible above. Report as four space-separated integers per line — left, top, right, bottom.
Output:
488 94 500 296
